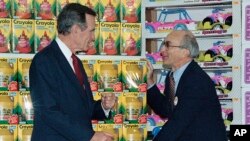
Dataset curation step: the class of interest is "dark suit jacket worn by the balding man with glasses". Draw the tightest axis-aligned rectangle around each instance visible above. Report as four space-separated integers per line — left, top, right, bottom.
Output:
147 61 227 141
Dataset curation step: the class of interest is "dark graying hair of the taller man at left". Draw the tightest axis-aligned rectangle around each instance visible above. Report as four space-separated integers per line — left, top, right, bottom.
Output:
57 3 96 35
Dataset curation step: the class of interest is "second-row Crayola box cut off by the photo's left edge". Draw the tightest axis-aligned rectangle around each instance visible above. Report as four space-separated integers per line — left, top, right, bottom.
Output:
0 19 11 53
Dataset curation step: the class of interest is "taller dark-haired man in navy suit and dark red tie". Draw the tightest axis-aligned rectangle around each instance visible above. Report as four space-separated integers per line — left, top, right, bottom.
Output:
30 3 115 141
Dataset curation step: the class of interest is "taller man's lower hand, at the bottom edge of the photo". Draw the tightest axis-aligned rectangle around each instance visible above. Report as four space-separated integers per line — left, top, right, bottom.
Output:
90 131 114 141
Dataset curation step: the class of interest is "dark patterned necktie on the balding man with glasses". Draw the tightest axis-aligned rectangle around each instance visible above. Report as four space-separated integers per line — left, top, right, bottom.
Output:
169 72 175 110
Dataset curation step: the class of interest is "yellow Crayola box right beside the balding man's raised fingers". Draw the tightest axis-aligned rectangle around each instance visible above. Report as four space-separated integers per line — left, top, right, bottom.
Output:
122 60 147 92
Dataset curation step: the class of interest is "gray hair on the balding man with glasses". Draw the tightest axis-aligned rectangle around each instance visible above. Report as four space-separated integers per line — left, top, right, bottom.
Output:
181 31 199 58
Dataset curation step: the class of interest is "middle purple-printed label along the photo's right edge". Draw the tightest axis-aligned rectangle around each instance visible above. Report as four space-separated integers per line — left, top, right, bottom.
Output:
244 48 250 84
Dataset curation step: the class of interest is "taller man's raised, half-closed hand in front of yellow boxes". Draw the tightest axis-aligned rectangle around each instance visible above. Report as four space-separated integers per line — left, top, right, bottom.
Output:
102 92 116 110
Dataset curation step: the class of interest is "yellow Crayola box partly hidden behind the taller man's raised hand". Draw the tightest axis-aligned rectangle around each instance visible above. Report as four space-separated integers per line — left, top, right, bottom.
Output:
93 92 123 124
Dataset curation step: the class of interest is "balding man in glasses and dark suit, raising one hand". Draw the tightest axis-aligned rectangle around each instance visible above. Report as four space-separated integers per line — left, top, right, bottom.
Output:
147 31 227 141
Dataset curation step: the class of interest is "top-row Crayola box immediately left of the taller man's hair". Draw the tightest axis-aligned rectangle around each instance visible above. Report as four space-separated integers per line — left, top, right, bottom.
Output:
34 0 56 20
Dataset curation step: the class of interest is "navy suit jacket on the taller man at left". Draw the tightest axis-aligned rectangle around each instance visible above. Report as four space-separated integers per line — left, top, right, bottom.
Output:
30 41 105 141
